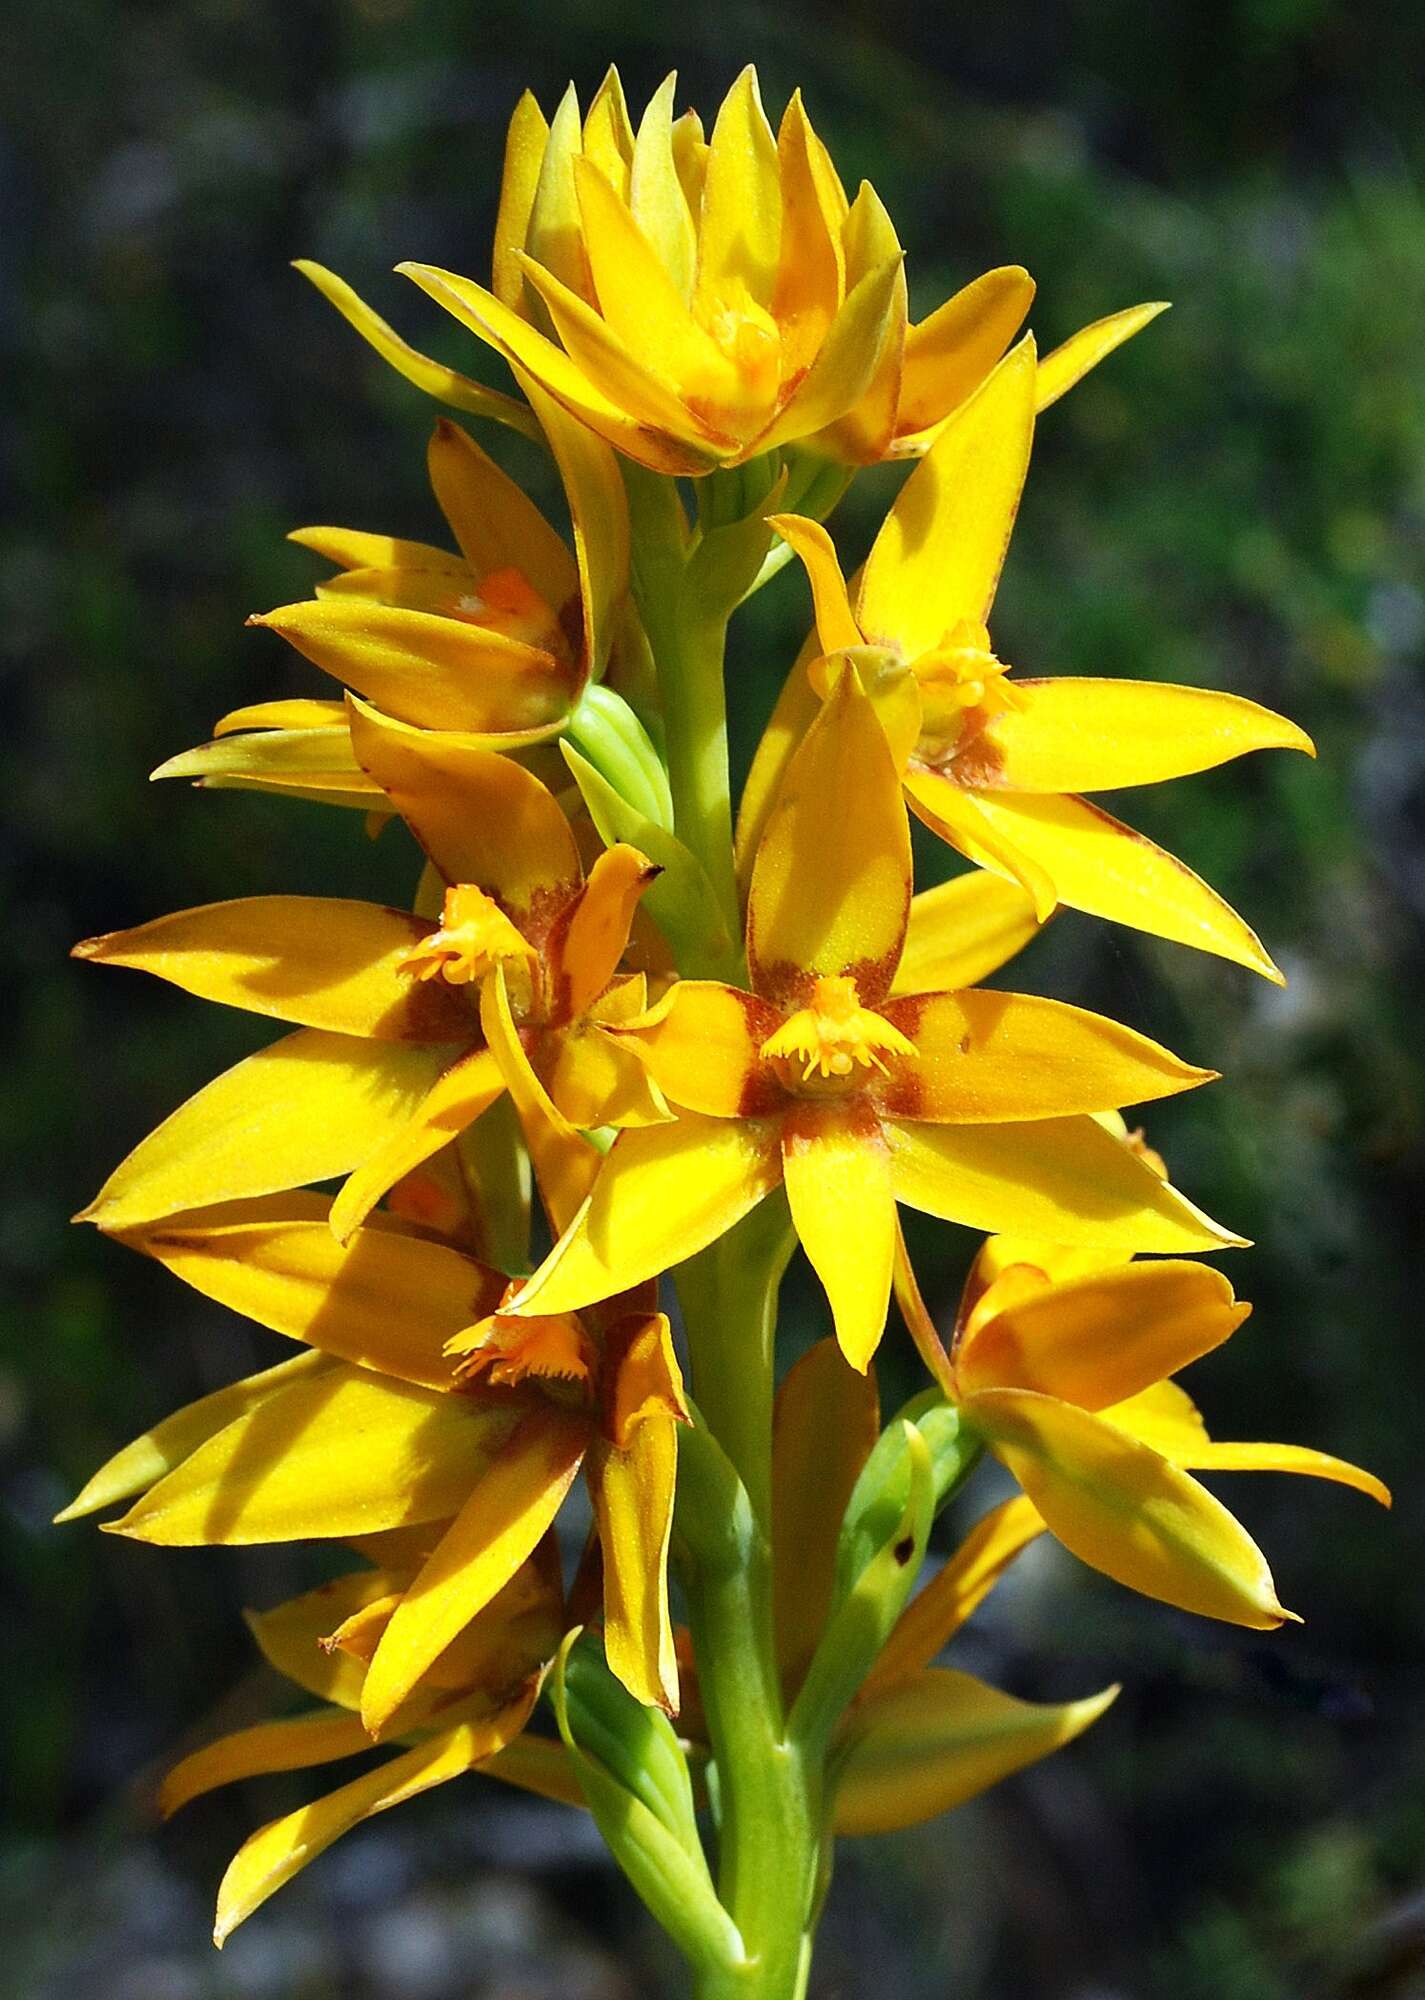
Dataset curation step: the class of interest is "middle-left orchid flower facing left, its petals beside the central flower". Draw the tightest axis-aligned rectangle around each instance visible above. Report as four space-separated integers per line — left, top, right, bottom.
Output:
74 728 666 1234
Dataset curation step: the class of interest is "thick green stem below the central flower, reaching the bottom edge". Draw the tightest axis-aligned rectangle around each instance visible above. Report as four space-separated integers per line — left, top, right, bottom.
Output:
678 1198 827 2000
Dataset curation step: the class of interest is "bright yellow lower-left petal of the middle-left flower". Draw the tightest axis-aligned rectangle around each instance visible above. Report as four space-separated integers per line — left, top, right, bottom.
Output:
76 1028 450 1230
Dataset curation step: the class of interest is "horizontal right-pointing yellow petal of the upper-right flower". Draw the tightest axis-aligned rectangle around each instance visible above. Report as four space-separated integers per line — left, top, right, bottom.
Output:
955 678 1315 792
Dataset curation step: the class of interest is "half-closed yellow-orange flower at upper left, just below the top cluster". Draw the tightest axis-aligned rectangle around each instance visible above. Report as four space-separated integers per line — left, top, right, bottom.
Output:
154 386 628 812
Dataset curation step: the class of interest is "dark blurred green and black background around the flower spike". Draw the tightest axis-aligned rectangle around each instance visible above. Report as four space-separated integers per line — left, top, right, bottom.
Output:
0 0 1425 2000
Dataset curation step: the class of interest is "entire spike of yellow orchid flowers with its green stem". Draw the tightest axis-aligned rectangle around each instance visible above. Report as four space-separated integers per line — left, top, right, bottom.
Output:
62 72 1385 1994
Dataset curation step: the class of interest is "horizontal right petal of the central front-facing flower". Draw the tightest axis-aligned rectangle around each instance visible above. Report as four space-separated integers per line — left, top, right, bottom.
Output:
877 986 1217 1124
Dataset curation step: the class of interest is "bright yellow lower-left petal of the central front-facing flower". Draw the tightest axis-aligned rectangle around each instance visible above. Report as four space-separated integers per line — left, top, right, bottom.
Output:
510 1114 783 1316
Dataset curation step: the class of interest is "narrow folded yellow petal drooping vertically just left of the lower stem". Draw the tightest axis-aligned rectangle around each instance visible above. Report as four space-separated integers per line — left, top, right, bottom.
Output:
588 1416 678 1714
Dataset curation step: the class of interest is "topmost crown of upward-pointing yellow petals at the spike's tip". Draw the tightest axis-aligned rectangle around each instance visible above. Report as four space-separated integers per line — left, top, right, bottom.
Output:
298 66 1163 474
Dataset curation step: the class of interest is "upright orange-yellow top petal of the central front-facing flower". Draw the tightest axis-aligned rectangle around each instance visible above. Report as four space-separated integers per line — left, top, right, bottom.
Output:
747 670 911 1006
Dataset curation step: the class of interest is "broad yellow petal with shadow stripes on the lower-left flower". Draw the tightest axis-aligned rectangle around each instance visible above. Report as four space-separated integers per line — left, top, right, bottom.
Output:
114 1368 514 1548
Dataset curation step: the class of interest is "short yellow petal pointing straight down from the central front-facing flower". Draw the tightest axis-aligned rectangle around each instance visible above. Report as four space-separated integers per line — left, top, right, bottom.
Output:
783 1098 897 1374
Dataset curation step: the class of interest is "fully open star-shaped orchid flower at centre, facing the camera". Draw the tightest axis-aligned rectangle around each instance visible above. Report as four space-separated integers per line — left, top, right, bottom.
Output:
516 672 1235 1368
